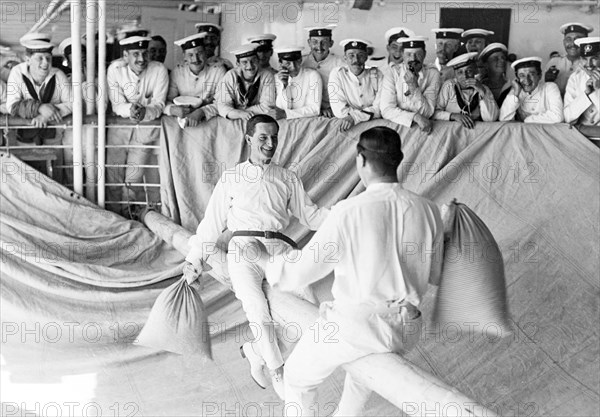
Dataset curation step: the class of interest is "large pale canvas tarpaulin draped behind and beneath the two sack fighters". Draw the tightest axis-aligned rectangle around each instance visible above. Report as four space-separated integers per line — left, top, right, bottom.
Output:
0 117 600 416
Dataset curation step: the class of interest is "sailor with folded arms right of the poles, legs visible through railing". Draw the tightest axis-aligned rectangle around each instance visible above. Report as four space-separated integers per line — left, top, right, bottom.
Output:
106 36 169 213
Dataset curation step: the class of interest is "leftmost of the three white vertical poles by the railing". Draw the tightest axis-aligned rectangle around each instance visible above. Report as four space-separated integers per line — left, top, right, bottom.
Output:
71 0 83 195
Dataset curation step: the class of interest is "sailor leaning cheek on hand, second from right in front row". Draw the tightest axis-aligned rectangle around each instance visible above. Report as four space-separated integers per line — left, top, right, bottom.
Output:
500 56 563 123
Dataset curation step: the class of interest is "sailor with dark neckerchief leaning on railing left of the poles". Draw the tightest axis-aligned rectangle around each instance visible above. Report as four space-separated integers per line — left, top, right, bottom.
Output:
6 40 73 180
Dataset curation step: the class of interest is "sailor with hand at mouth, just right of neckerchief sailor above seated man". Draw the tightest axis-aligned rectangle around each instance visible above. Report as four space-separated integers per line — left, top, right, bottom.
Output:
275 47 323 119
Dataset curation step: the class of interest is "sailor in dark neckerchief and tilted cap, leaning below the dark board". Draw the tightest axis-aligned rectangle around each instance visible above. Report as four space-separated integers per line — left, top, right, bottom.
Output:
433 52 498 129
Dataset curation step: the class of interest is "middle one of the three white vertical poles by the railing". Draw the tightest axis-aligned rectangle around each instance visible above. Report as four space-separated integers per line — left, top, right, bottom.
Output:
84 0 98 202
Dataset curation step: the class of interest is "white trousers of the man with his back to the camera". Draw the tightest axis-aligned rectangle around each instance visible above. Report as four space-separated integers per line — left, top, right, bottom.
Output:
284 312 422 417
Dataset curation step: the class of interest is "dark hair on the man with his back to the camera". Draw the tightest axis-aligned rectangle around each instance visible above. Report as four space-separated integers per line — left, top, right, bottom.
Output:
356 126 404 175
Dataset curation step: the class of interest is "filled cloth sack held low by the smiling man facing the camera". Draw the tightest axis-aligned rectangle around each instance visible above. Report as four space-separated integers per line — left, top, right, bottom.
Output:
138 275 212 359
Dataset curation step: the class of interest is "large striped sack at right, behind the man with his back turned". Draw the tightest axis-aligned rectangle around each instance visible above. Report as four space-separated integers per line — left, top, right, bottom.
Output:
433 202 512 338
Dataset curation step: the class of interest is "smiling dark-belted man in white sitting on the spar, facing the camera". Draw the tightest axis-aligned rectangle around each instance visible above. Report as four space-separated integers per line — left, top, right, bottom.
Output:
186 115 329 398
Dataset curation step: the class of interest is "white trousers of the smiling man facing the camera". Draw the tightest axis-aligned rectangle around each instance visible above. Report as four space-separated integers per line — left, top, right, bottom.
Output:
227 236 288 369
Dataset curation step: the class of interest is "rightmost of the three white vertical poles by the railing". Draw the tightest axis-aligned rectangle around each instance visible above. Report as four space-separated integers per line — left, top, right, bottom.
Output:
98 0 108 208
